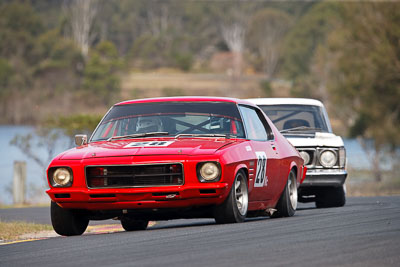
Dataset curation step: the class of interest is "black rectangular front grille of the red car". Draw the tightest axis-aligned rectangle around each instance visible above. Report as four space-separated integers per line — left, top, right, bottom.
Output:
86 163 184 188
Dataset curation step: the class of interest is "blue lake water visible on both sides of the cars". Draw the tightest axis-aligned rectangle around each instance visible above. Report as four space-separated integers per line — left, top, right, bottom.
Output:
0 125 369 204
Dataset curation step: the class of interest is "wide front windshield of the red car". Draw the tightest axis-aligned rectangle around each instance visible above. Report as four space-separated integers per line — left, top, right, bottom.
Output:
91 102 245 141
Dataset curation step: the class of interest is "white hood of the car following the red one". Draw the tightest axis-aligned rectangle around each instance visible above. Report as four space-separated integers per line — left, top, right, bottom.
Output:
286 132 344 147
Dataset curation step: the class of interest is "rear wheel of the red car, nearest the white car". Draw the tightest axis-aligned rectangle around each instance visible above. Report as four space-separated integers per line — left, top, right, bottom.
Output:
270 170 297 218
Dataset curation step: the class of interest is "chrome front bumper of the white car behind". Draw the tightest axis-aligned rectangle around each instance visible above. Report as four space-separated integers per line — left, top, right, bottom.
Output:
300 169 347 188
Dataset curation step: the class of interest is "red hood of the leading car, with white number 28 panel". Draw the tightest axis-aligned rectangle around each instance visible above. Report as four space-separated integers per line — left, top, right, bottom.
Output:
59 138 236 160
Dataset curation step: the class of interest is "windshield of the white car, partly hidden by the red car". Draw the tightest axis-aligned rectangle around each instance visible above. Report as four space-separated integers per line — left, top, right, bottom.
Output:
260 105 331 133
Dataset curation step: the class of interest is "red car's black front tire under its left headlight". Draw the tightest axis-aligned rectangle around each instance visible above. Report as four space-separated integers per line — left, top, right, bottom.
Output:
50 201 89 236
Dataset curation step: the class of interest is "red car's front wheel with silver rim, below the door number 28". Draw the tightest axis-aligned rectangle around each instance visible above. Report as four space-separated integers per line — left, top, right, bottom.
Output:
214 170 249 224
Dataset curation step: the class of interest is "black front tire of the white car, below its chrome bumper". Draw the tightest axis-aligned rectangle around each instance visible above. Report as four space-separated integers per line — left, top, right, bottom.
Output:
315 186 346 208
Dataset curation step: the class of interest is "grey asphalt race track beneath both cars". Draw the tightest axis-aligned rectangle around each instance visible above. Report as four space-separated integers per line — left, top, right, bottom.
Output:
0 196 400 267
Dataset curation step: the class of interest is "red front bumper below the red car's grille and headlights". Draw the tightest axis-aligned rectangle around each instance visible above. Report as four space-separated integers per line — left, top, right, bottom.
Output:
46 183 229 210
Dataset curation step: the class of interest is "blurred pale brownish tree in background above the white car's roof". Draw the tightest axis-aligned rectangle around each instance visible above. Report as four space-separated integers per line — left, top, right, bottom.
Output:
247 8 291 79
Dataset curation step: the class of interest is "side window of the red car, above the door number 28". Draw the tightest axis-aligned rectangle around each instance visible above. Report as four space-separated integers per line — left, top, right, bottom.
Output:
239 106 273 141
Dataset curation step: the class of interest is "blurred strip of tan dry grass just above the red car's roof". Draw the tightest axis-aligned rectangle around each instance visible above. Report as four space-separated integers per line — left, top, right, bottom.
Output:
121 71 289 99
